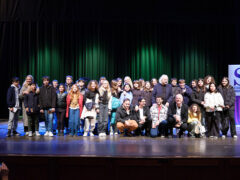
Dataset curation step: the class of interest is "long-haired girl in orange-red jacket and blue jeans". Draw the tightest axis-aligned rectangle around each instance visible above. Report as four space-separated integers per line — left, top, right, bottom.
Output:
66 84 83 136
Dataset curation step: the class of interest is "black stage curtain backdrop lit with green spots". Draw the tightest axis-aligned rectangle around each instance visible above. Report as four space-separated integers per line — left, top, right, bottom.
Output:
0 0 239 117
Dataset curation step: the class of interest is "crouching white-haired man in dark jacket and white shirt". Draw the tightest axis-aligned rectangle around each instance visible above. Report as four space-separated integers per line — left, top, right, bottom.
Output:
167 94 188 138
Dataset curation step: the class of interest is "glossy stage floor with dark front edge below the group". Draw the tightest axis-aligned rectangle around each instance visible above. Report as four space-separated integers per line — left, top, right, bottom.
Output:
0 122 240 180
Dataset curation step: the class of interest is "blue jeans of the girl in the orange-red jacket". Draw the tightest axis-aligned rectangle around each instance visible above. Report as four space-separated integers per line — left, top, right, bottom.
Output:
68 109 80 135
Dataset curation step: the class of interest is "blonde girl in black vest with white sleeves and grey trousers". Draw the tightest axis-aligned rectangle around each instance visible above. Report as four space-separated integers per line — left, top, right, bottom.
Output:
98 80 112 137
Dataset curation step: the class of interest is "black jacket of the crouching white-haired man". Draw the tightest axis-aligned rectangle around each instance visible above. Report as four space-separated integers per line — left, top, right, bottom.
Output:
167 103 188 124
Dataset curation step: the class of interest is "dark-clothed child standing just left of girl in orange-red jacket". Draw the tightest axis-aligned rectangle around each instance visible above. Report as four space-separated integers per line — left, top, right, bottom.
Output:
57 84 67 136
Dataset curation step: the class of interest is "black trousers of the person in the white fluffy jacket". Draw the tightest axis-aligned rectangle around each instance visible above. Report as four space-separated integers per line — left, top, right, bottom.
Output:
206 111 222 137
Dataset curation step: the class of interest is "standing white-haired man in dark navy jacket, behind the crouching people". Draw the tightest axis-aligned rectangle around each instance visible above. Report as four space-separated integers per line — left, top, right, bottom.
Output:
152 74 173 107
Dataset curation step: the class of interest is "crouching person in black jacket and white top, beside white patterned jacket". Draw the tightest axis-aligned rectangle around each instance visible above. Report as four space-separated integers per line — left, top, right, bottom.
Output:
134 97 152 136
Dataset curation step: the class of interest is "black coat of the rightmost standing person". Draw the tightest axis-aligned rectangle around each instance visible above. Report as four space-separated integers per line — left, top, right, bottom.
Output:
218 85 236 111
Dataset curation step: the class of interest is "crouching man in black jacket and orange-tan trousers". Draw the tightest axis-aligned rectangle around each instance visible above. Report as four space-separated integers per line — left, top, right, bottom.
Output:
116 98 138 136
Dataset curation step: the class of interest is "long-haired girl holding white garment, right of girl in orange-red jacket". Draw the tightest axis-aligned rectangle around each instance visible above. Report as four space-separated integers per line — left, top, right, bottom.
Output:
81 80 99 136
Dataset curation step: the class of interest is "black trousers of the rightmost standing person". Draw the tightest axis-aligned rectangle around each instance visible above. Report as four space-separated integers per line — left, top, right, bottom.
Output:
221 109 237 136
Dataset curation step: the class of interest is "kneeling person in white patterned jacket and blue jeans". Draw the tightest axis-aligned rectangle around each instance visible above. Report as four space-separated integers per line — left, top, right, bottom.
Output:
150 96 168 137
